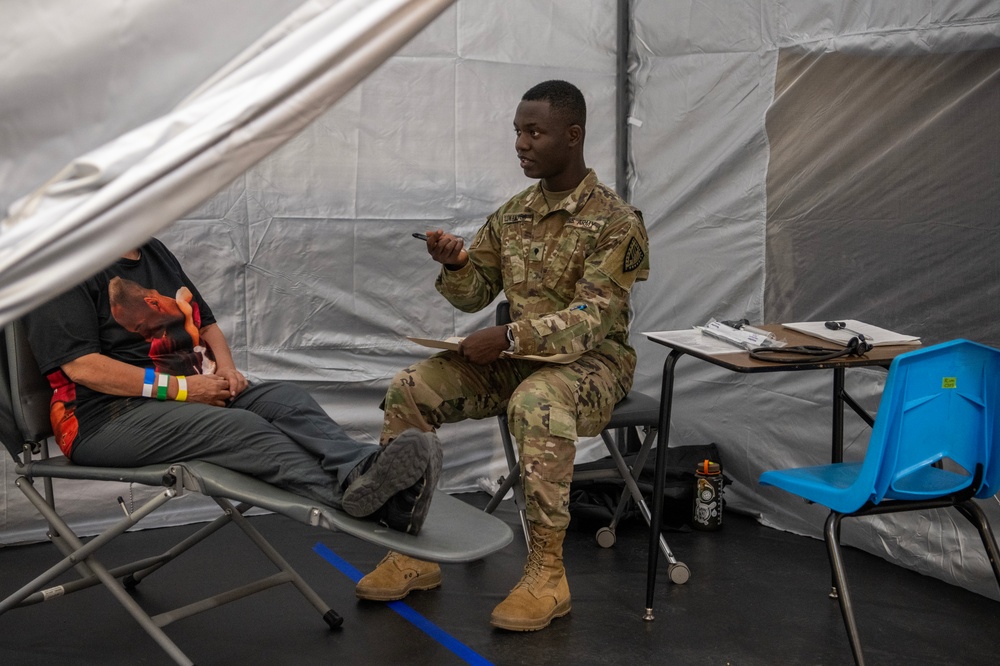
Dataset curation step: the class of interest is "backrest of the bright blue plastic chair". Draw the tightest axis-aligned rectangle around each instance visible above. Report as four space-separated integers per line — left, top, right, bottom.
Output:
861 340 1000 502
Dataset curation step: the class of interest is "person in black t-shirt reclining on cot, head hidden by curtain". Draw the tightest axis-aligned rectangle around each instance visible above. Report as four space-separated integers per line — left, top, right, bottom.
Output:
26 239 441 534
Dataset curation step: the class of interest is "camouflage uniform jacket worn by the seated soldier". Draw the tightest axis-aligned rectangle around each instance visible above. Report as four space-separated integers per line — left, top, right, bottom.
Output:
435 170 649 384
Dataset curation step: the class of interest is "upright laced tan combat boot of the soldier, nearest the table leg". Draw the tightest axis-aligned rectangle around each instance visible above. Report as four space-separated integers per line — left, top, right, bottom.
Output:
490 523 570 631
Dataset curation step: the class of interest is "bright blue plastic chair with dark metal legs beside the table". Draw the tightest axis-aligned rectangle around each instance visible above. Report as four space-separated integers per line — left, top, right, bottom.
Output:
760 340 1000 664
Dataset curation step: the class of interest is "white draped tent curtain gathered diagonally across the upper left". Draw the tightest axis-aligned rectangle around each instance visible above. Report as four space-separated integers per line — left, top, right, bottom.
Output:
0 0 454 324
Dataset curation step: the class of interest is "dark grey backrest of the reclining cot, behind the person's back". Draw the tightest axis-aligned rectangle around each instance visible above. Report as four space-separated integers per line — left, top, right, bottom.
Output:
2 320 52 458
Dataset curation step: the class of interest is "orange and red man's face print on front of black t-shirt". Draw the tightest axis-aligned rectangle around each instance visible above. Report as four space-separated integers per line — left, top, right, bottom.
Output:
108 277 215 375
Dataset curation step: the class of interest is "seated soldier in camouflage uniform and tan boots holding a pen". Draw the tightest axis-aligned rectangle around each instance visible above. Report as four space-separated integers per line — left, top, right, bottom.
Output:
357 81 649 631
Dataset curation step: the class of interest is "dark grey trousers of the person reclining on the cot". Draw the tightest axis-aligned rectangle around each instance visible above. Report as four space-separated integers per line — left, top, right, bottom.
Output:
72 382 378 508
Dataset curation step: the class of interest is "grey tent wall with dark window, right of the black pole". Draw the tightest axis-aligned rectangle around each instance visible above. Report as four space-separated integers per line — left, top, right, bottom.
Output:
630 0 1000 598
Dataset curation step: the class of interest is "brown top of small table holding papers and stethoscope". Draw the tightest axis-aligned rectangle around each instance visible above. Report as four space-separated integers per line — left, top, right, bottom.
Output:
645 324 920 372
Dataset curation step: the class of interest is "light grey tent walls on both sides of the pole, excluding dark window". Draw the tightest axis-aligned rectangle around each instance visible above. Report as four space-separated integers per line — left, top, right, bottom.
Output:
0 0 1000 596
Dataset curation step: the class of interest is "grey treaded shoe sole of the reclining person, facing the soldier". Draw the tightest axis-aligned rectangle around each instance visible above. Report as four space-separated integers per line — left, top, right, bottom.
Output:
341 430 440 518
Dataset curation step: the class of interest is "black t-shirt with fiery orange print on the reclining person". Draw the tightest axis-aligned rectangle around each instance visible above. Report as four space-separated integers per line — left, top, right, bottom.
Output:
26 238 215 456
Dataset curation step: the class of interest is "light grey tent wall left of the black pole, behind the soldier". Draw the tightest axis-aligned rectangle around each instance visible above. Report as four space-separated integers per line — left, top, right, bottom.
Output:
0 0 616 543
